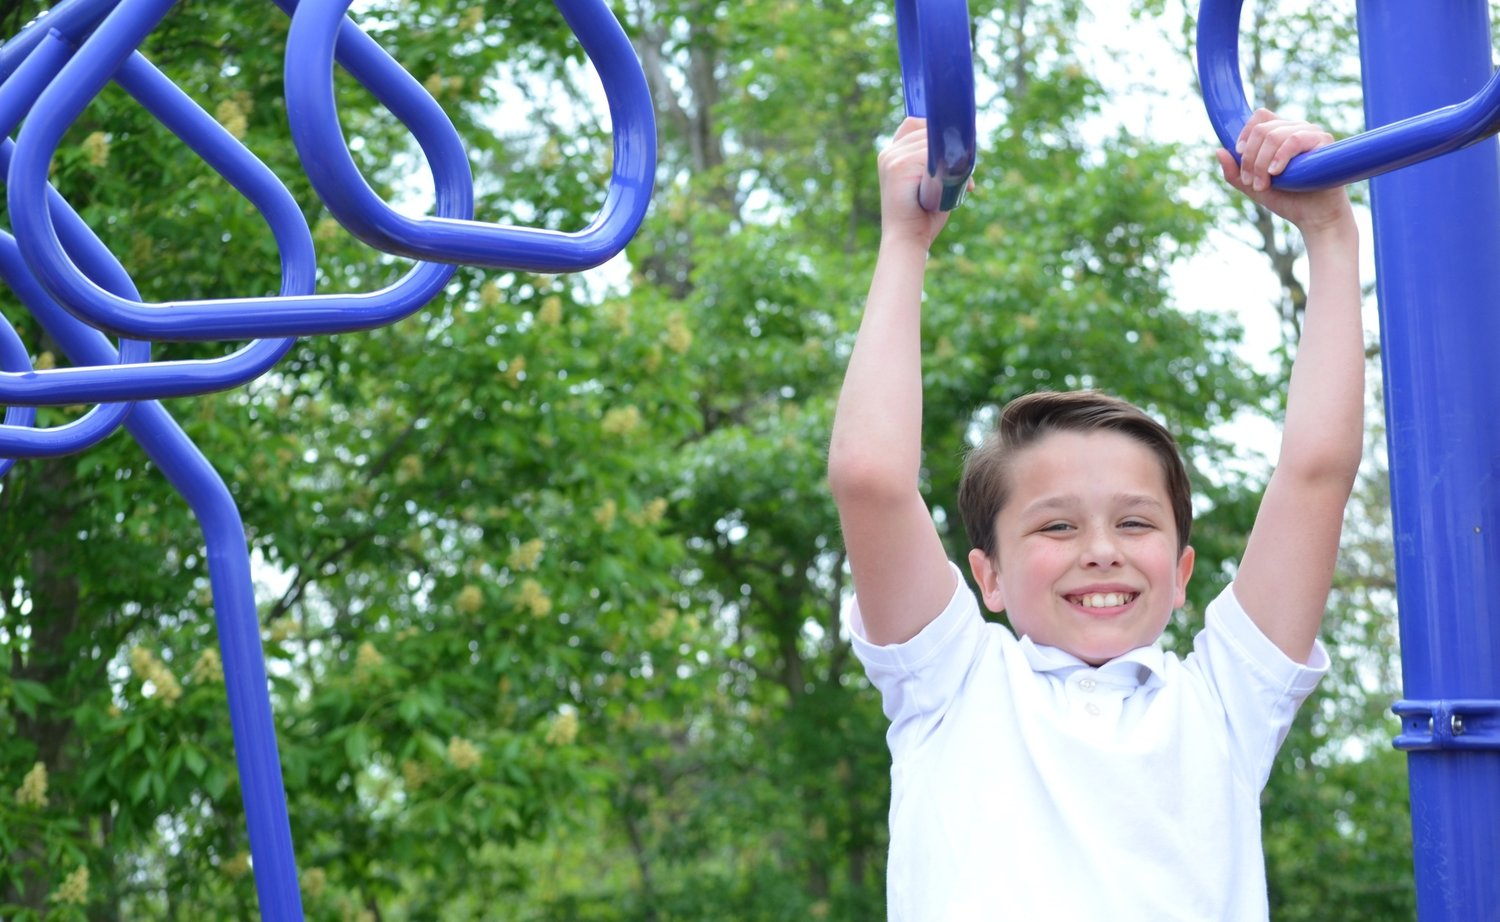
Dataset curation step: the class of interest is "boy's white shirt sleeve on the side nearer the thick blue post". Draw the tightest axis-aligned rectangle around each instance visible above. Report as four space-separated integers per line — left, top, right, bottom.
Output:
1193 583 1329 790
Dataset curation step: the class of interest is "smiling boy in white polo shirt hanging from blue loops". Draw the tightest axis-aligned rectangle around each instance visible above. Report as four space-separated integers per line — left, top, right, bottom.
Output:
828 111 1365 922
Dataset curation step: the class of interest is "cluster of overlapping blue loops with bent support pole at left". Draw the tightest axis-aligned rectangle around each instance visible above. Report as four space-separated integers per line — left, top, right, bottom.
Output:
0 0 656 922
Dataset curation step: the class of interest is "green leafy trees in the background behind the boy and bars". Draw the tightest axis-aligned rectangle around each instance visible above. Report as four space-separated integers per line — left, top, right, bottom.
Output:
0 0 1394 921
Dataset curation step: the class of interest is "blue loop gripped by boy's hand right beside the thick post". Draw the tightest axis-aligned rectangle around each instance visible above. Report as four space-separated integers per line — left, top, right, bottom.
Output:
1197 0 1500 192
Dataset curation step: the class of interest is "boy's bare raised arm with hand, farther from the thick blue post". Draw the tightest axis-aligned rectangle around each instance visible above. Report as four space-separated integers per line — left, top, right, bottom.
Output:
828 118 957 645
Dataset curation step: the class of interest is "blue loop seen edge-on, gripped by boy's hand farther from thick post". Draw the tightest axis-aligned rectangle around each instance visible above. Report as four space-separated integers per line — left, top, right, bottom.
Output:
896 0 978 211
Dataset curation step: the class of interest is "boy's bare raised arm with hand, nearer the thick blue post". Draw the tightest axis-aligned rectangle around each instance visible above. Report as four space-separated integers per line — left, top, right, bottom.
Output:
1220 109 1365 663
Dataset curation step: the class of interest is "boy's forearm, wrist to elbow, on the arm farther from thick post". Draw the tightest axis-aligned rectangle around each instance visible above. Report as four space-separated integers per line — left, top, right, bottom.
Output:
830 237 927 493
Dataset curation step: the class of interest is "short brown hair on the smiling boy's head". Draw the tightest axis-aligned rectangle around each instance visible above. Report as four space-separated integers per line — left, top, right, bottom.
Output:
959 390 1193 558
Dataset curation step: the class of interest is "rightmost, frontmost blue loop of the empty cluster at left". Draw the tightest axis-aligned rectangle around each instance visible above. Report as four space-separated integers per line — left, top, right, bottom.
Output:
287 0 657 273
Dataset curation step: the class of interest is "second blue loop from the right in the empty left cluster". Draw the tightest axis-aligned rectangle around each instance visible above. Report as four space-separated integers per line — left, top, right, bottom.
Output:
8 0 473 343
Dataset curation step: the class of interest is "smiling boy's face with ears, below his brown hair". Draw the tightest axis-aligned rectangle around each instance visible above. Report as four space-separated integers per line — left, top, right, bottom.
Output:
969 430 1193 666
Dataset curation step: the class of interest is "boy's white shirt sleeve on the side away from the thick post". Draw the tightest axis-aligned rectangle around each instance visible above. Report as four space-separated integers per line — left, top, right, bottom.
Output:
849 562 986 762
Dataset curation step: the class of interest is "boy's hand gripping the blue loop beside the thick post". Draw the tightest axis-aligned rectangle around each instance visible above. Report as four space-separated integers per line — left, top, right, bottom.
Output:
1218 109 1350 234
